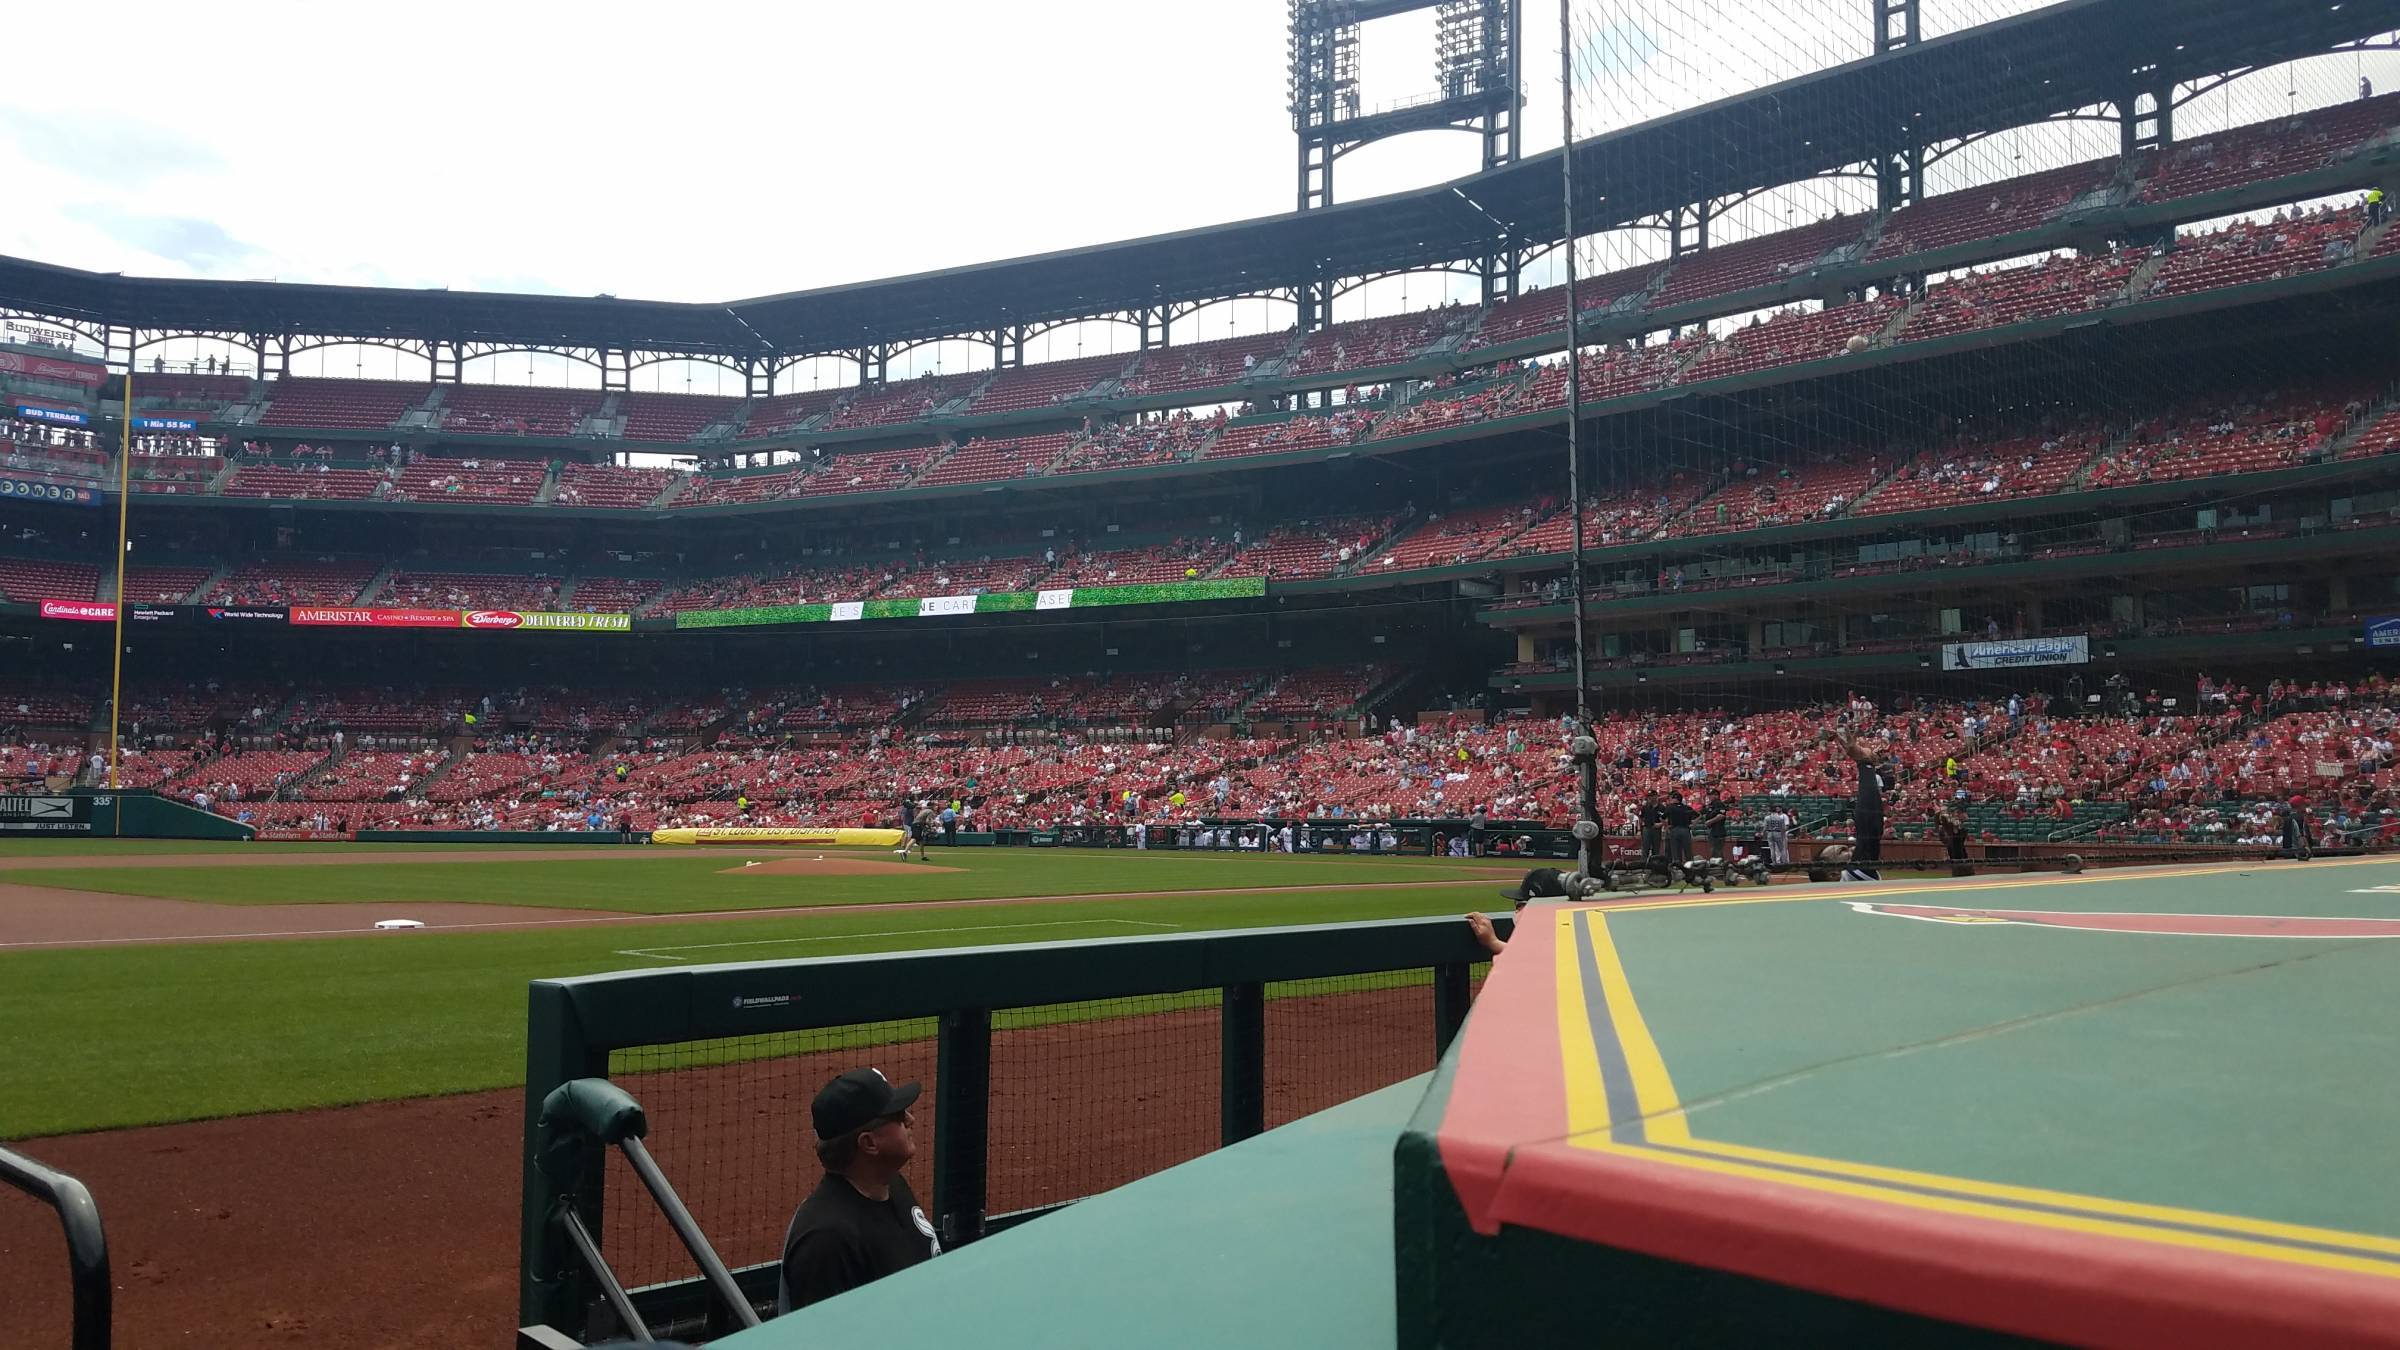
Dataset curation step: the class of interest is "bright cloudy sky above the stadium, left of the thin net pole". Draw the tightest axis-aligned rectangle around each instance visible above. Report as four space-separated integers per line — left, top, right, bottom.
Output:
0 0 1558 300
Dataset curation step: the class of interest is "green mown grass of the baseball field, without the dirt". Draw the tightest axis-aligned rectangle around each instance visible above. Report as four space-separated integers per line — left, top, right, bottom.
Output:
0 846 1505 1139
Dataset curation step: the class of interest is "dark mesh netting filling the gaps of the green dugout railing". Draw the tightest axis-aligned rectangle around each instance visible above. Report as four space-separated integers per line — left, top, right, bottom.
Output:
580 968 1483 1288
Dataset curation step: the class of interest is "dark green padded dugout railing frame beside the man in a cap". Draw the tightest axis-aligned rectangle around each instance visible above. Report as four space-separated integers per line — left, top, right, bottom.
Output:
518 915 1510 1336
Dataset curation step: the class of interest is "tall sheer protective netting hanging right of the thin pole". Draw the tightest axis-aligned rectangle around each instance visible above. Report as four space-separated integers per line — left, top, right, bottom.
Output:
1514 0 2400 848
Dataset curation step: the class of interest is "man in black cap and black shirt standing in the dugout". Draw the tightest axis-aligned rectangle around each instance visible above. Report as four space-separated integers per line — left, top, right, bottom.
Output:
775 1069 941 1316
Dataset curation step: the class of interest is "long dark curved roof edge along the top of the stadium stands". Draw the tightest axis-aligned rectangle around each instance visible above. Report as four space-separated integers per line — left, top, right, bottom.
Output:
0 0 2400 360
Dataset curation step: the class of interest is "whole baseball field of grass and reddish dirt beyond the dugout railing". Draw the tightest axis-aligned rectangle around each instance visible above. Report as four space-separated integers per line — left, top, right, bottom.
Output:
0 841 1517 1345
